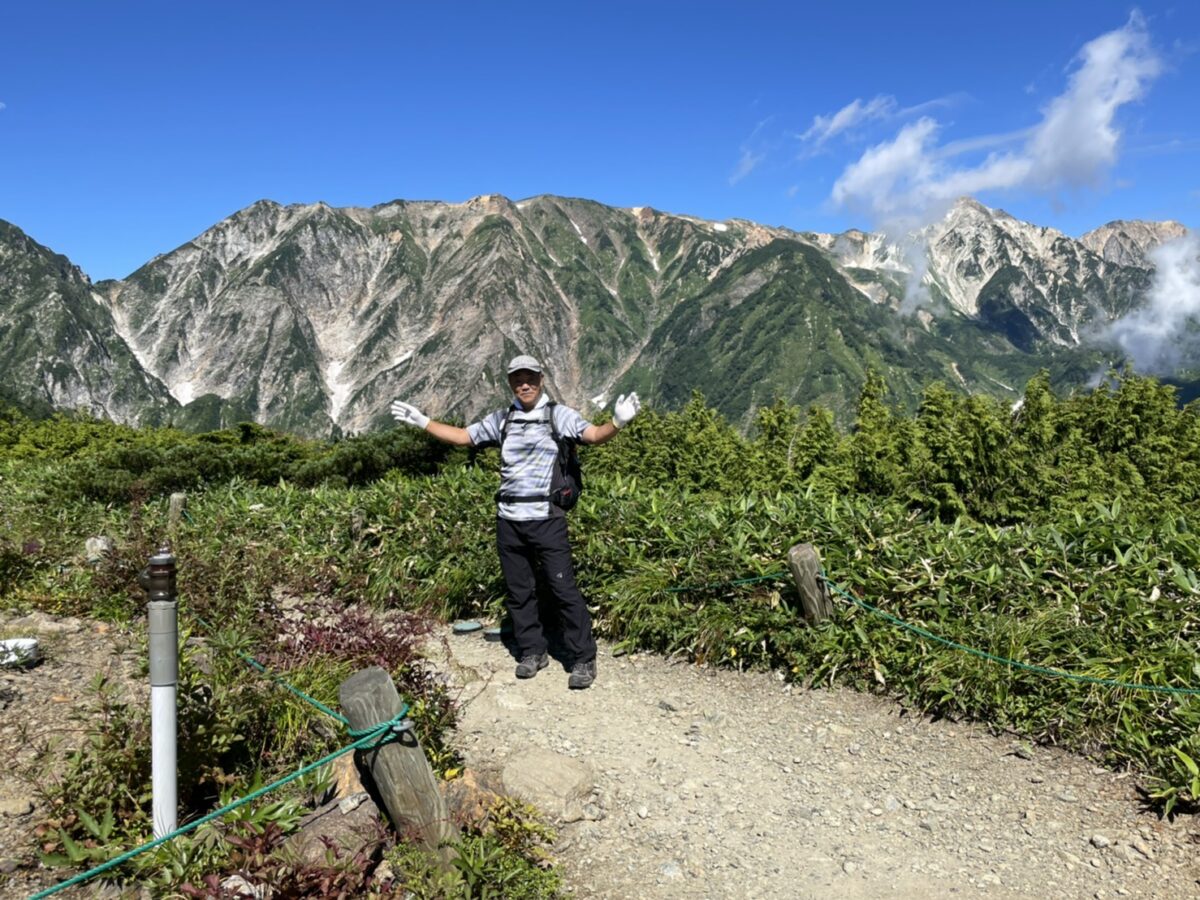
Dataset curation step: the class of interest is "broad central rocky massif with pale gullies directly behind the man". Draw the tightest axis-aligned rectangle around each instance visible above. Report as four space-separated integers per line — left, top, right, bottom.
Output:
93 196 782 433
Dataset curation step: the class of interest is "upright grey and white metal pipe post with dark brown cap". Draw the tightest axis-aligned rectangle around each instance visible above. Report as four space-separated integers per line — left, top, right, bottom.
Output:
138 546 179 838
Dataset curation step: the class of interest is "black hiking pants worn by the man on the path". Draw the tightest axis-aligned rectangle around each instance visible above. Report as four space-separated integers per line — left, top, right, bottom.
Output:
496 516 596 662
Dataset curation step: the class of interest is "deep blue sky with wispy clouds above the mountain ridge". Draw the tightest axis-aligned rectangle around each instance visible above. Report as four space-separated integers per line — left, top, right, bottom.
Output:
0 0 1200 280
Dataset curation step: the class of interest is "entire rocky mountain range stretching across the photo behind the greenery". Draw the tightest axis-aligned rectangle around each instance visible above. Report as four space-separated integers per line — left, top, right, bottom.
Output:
0 196 1181 434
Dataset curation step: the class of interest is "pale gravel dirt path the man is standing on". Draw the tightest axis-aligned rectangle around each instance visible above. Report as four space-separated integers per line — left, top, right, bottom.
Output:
448 636 1200 900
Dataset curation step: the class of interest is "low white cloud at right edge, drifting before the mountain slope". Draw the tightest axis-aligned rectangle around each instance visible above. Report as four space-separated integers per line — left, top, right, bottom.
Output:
1109 233 1200 374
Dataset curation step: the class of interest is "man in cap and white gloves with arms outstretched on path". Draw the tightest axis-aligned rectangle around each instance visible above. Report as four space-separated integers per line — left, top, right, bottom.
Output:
391 355 641 689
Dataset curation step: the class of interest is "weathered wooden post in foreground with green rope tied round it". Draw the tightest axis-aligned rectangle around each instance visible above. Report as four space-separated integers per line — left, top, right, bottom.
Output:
337 666 457 862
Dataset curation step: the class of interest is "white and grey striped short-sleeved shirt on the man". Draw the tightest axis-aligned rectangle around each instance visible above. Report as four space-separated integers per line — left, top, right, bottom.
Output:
467 394 592 522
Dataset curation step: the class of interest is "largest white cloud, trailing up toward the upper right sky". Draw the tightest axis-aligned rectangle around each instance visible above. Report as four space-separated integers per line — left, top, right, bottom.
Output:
830 13 1162 233
